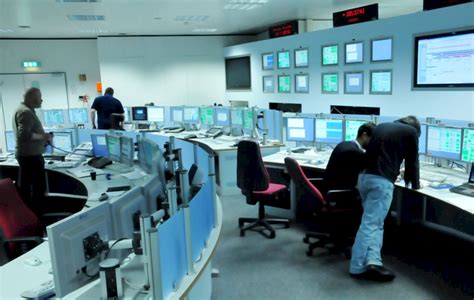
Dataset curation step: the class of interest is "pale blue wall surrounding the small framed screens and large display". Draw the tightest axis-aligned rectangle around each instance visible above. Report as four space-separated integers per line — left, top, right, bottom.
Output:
225 3 474 120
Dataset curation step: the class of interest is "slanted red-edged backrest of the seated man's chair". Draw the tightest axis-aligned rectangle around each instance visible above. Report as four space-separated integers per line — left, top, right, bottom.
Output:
285 157 326 210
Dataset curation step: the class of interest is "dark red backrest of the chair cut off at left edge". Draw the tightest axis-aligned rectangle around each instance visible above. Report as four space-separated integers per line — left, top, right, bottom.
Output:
0 178 43 254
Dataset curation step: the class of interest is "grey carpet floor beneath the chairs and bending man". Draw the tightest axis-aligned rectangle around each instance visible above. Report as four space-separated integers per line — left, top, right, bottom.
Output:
212 196 472 300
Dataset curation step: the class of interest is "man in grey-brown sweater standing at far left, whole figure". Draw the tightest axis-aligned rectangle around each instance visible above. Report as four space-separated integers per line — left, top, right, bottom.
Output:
13 87 53 214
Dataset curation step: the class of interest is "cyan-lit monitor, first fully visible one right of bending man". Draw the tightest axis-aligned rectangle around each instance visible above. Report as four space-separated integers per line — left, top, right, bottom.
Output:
426 126 462 160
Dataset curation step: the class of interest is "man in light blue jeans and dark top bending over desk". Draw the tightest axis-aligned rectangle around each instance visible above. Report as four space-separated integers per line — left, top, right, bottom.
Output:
349 116 421 281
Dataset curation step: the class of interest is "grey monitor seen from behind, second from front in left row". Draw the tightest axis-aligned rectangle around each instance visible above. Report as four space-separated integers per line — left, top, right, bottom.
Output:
110 187 147 239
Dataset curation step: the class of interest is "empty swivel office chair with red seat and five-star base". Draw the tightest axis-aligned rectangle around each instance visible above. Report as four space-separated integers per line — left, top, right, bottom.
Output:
237 140 290 239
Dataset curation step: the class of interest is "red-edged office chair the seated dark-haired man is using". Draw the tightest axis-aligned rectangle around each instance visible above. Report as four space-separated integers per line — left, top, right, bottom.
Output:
285 157 360 258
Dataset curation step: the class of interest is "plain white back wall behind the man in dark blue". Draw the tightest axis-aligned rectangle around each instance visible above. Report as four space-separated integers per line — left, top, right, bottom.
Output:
98 36 255 106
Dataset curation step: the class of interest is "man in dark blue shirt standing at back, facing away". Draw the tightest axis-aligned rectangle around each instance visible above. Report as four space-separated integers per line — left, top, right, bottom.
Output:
91 87 125 129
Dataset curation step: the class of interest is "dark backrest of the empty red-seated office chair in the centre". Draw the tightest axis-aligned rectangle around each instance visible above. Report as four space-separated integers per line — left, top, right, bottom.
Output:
237 140 270 195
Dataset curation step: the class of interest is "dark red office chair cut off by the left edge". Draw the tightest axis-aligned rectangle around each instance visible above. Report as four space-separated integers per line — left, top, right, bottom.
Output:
0 178 44 260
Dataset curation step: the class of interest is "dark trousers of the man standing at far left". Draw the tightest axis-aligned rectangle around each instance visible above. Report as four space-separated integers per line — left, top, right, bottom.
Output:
17 155 46 215
